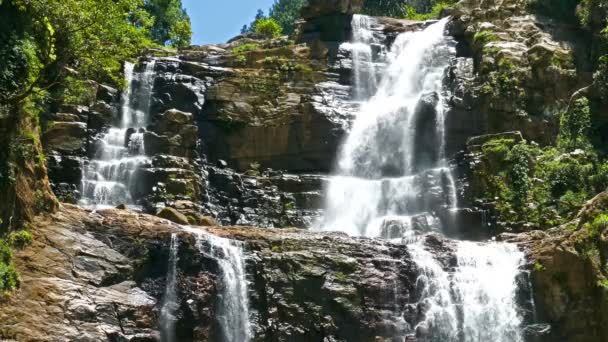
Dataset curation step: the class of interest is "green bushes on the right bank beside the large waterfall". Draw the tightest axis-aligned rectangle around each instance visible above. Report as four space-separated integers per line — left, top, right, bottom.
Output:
473 113 608 228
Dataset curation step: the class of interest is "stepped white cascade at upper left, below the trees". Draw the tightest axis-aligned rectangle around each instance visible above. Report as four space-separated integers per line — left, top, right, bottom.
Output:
80 60 155 208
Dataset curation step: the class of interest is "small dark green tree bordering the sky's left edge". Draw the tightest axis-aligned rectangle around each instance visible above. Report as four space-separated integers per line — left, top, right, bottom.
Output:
144 0 192 47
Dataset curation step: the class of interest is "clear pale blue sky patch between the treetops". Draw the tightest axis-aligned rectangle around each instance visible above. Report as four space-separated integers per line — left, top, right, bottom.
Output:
182 0 274 45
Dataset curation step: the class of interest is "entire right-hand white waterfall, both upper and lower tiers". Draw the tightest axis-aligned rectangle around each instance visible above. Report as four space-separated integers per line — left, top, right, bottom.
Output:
319 17 523 342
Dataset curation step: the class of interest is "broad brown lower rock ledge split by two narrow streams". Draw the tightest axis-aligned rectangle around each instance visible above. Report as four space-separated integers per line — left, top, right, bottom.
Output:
0 205 466 341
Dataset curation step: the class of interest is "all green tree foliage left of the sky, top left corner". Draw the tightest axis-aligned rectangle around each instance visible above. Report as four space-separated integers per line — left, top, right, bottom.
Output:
0 0 191 107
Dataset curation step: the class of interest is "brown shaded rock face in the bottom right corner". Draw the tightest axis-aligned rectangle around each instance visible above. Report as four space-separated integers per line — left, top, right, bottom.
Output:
505 192 608 342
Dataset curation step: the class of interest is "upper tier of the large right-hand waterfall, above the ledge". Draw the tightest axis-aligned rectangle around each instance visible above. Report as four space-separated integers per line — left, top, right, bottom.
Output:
321 17 456 237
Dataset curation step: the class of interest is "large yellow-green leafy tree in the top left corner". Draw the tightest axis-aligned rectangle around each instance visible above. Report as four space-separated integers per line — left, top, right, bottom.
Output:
0 0 151 103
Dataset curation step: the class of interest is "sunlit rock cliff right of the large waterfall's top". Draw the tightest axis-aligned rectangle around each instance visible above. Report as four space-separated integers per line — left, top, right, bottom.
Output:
448 0 585 146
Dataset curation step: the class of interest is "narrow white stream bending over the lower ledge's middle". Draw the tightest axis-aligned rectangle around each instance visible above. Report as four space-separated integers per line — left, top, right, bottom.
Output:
188 228 252 342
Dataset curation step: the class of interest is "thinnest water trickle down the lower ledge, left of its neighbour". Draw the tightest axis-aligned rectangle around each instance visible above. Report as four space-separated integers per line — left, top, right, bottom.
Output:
160 233 179 342
